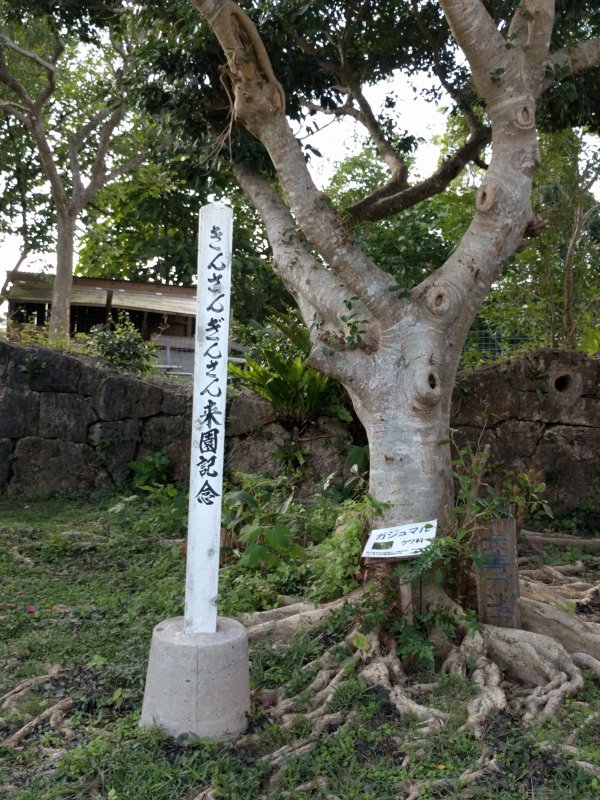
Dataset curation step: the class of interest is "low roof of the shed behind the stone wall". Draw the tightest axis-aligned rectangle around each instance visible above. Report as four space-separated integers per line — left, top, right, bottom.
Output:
8 271 196 317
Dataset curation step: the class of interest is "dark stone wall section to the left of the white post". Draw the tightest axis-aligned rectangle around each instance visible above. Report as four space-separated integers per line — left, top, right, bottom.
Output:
0 340 191 493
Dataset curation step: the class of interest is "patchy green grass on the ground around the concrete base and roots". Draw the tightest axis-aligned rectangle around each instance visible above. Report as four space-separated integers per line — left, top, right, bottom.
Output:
0 494 600 800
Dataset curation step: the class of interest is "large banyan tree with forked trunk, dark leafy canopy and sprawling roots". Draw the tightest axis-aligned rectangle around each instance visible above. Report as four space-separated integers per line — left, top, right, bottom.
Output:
134 0 600 776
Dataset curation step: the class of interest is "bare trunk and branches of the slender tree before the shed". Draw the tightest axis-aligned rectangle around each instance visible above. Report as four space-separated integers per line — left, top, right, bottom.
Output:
0 27 145 339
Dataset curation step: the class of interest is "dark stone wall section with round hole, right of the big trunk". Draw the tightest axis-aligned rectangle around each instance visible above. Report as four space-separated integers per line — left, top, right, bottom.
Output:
451 350 600 512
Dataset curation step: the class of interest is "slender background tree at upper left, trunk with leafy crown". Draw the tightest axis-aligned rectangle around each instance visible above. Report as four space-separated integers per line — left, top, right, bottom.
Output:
0 2 145 336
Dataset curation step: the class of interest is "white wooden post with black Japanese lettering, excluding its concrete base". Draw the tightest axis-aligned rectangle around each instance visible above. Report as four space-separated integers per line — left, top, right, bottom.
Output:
184 203 233 633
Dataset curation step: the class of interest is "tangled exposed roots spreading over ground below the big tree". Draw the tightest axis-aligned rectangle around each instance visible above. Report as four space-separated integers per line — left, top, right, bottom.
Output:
236 539 600 800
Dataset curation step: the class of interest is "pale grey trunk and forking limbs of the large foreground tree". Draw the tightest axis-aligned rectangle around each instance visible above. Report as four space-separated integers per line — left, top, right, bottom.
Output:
194 0 589 524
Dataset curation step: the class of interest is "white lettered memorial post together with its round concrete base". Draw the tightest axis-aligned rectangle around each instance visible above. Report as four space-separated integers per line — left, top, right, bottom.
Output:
140 203 250 739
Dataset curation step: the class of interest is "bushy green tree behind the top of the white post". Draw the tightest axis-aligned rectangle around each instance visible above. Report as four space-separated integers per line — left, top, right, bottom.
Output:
77 159 291 322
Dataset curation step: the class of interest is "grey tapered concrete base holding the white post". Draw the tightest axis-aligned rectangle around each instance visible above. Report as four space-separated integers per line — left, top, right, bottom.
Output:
140 617 250 739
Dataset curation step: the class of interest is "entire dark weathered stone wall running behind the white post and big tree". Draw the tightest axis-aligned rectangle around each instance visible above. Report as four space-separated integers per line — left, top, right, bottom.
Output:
0 341 600 510
